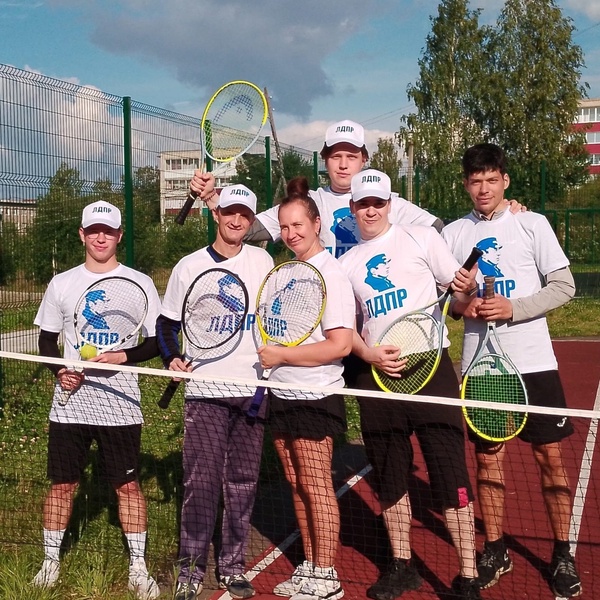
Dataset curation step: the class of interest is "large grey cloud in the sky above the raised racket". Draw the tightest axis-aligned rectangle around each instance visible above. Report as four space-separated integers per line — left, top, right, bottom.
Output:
50 0 375 118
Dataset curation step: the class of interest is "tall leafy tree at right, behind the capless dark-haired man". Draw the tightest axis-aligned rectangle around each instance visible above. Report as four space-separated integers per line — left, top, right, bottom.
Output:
484 0 587 208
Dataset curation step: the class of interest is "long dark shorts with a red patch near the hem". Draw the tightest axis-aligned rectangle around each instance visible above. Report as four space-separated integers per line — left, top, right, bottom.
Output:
357 351 474 508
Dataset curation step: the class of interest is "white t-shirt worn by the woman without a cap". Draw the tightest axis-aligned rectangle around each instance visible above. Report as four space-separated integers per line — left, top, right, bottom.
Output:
269 250 355 400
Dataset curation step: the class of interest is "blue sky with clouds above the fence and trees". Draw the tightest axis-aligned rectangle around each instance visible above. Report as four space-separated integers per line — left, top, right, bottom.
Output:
0 0 600 149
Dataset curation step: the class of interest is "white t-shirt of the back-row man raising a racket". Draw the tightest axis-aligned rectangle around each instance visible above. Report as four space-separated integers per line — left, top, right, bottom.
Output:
256 187 436 258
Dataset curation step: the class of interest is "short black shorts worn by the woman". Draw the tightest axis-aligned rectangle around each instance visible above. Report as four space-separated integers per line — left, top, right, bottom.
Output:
269 393 348 441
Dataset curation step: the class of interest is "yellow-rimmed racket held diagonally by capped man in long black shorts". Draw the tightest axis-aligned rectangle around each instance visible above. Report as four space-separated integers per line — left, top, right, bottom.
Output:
371 248 483 394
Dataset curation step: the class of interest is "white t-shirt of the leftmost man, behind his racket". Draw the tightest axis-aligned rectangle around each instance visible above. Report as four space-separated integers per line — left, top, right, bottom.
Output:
34 265 160 425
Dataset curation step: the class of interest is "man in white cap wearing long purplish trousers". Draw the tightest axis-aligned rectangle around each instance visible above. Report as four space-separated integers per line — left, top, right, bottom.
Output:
157 185 273 600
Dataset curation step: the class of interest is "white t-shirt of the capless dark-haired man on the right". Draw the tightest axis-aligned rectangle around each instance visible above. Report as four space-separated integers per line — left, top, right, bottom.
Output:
442 210 569 373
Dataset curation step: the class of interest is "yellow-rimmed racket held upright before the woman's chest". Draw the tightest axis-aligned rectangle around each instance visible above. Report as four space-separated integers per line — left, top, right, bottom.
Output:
247 260 327 417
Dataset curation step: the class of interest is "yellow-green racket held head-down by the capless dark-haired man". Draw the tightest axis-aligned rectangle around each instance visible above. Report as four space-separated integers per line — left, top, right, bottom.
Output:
460 277 528 442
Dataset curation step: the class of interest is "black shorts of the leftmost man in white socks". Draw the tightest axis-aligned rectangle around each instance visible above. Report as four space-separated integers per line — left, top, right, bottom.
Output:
48 421 142 486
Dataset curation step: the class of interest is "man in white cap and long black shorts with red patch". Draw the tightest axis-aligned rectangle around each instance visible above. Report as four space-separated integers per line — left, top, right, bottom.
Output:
340 169 480 600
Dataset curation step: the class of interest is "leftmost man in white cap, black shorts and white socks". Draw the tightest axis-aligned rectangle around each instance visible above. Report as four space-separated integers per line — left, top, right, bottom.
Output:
33 201 160 600
